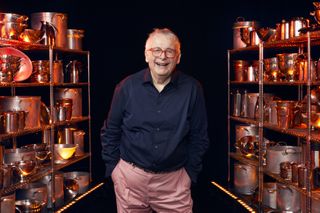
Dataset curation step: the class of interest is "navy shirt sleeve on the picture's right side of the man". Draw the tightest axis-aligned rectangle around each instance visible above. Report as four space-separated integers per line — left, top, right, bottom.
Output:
185 83 209 183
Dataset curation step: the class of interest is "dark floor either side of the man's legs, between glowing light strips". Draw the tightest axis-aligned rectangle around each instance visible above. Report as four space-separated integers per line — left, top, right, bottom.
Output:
61 182 248 213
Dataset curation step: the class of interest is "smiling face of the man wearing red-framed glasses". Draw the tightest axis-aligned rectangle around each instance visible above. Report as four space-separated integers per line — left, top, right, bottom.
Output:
145 34 181 77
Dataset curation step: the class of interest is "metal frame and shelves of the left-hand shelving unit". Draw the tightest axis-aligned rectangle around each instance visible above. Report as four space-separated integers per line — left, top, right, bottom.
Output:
0 38 92 212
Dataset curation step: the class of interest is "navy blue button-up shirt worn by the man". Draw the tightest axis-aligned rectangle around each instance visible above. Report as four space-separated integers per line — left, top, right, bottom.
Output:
101 69 209 182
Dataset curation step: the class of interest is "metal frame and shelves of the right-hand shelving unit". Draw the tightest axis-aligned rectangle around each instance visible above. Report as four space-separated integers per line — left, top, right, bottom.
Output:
227 31 320 212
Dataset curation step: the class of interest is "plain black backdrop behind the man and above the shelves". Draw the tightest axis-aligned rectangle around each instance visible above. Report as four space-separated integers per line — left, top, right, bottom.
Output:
0 0 314 185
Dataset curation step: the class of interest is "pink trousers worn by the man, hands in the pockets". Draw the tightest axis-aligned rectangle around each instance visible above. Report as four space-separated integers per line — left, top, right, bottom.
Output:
111 160 193 213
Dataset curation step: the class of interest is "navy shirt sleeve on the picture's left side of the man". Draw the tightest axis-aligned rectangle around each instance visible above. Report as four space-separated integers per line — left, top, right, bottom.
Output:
100 84 124 177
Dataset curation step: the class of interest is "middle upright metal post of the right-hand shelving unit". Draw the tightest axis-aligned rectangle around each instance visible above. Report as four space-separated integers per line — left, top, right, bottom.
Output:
258 42 265 212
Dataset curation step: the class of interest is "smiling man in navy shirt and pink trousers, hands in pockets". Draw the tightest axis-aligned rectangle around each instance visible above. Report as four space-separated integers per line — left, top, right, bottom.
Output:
101 28 209 213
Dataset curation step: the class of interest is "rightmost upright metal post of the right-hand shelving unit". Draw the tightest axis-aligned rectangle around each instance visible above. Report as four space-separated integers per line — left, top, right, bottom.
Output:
305 31 312 212
